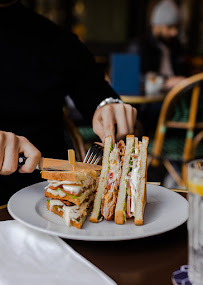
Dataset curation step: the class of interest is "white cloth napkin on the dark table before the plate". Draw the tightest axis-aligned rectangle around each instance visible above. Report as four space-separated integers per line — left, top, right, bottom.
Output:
0 221 116 285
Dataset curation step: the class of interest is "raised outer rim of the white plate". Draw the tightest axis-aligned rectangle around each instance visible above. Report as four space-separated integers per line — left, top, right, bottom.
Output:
7 181 188 242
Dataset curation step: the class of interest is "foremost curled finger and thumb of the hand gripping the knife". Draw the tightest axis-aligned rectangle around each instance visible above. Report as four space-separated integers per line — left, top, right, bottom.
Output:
18 137 41 173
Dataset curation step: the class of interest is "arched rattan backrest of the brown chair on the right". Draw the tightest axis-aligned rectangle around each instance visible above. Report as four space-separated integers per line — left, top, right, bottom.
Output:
151 73 203 166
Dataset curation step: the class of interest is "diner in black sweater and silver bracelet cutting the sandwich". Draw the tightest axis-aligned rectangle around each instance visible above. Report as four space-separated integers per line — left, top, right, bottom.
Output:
0 0 137 204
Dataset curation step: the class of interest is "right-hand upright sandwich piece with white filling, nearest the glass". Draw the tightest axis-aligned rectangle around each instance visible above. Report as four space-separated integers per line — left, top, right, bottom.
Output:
115 135 149 225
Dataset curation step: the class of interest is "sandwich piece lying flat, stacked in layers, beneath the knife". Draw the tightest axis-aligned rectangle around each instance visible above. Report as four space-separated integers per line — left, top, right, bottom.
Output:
41 164 100 229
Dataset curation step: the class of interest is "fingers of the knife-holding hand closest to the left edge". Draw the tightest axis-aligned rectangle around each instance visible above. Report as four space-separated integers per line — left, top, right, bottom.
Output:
0 132 19 175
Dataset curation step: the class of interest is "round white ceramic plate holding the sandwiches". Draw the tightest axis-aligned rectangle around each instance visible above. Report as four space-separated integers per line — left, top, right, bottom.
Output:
8 182 188 241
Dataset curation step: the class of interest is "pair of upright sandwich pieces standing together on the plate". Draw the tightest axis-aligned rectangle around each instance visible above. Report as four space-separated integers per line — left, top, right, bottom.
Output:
90 135 149 225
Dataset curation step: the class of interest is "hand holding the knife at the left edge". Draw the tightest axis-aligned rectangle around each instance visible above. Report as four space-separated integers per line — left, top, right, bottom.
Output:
0 131 41 175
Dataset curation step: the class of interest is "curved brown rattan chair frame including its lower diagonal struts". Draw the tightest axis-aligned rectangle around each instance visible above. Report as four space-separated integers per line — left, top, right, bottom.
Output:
148 73 203 187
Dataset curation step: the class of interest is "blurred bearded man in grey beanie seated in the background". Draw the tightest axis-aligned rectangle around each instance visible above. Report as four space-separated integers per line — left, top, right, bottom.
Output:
141 0 186 89
